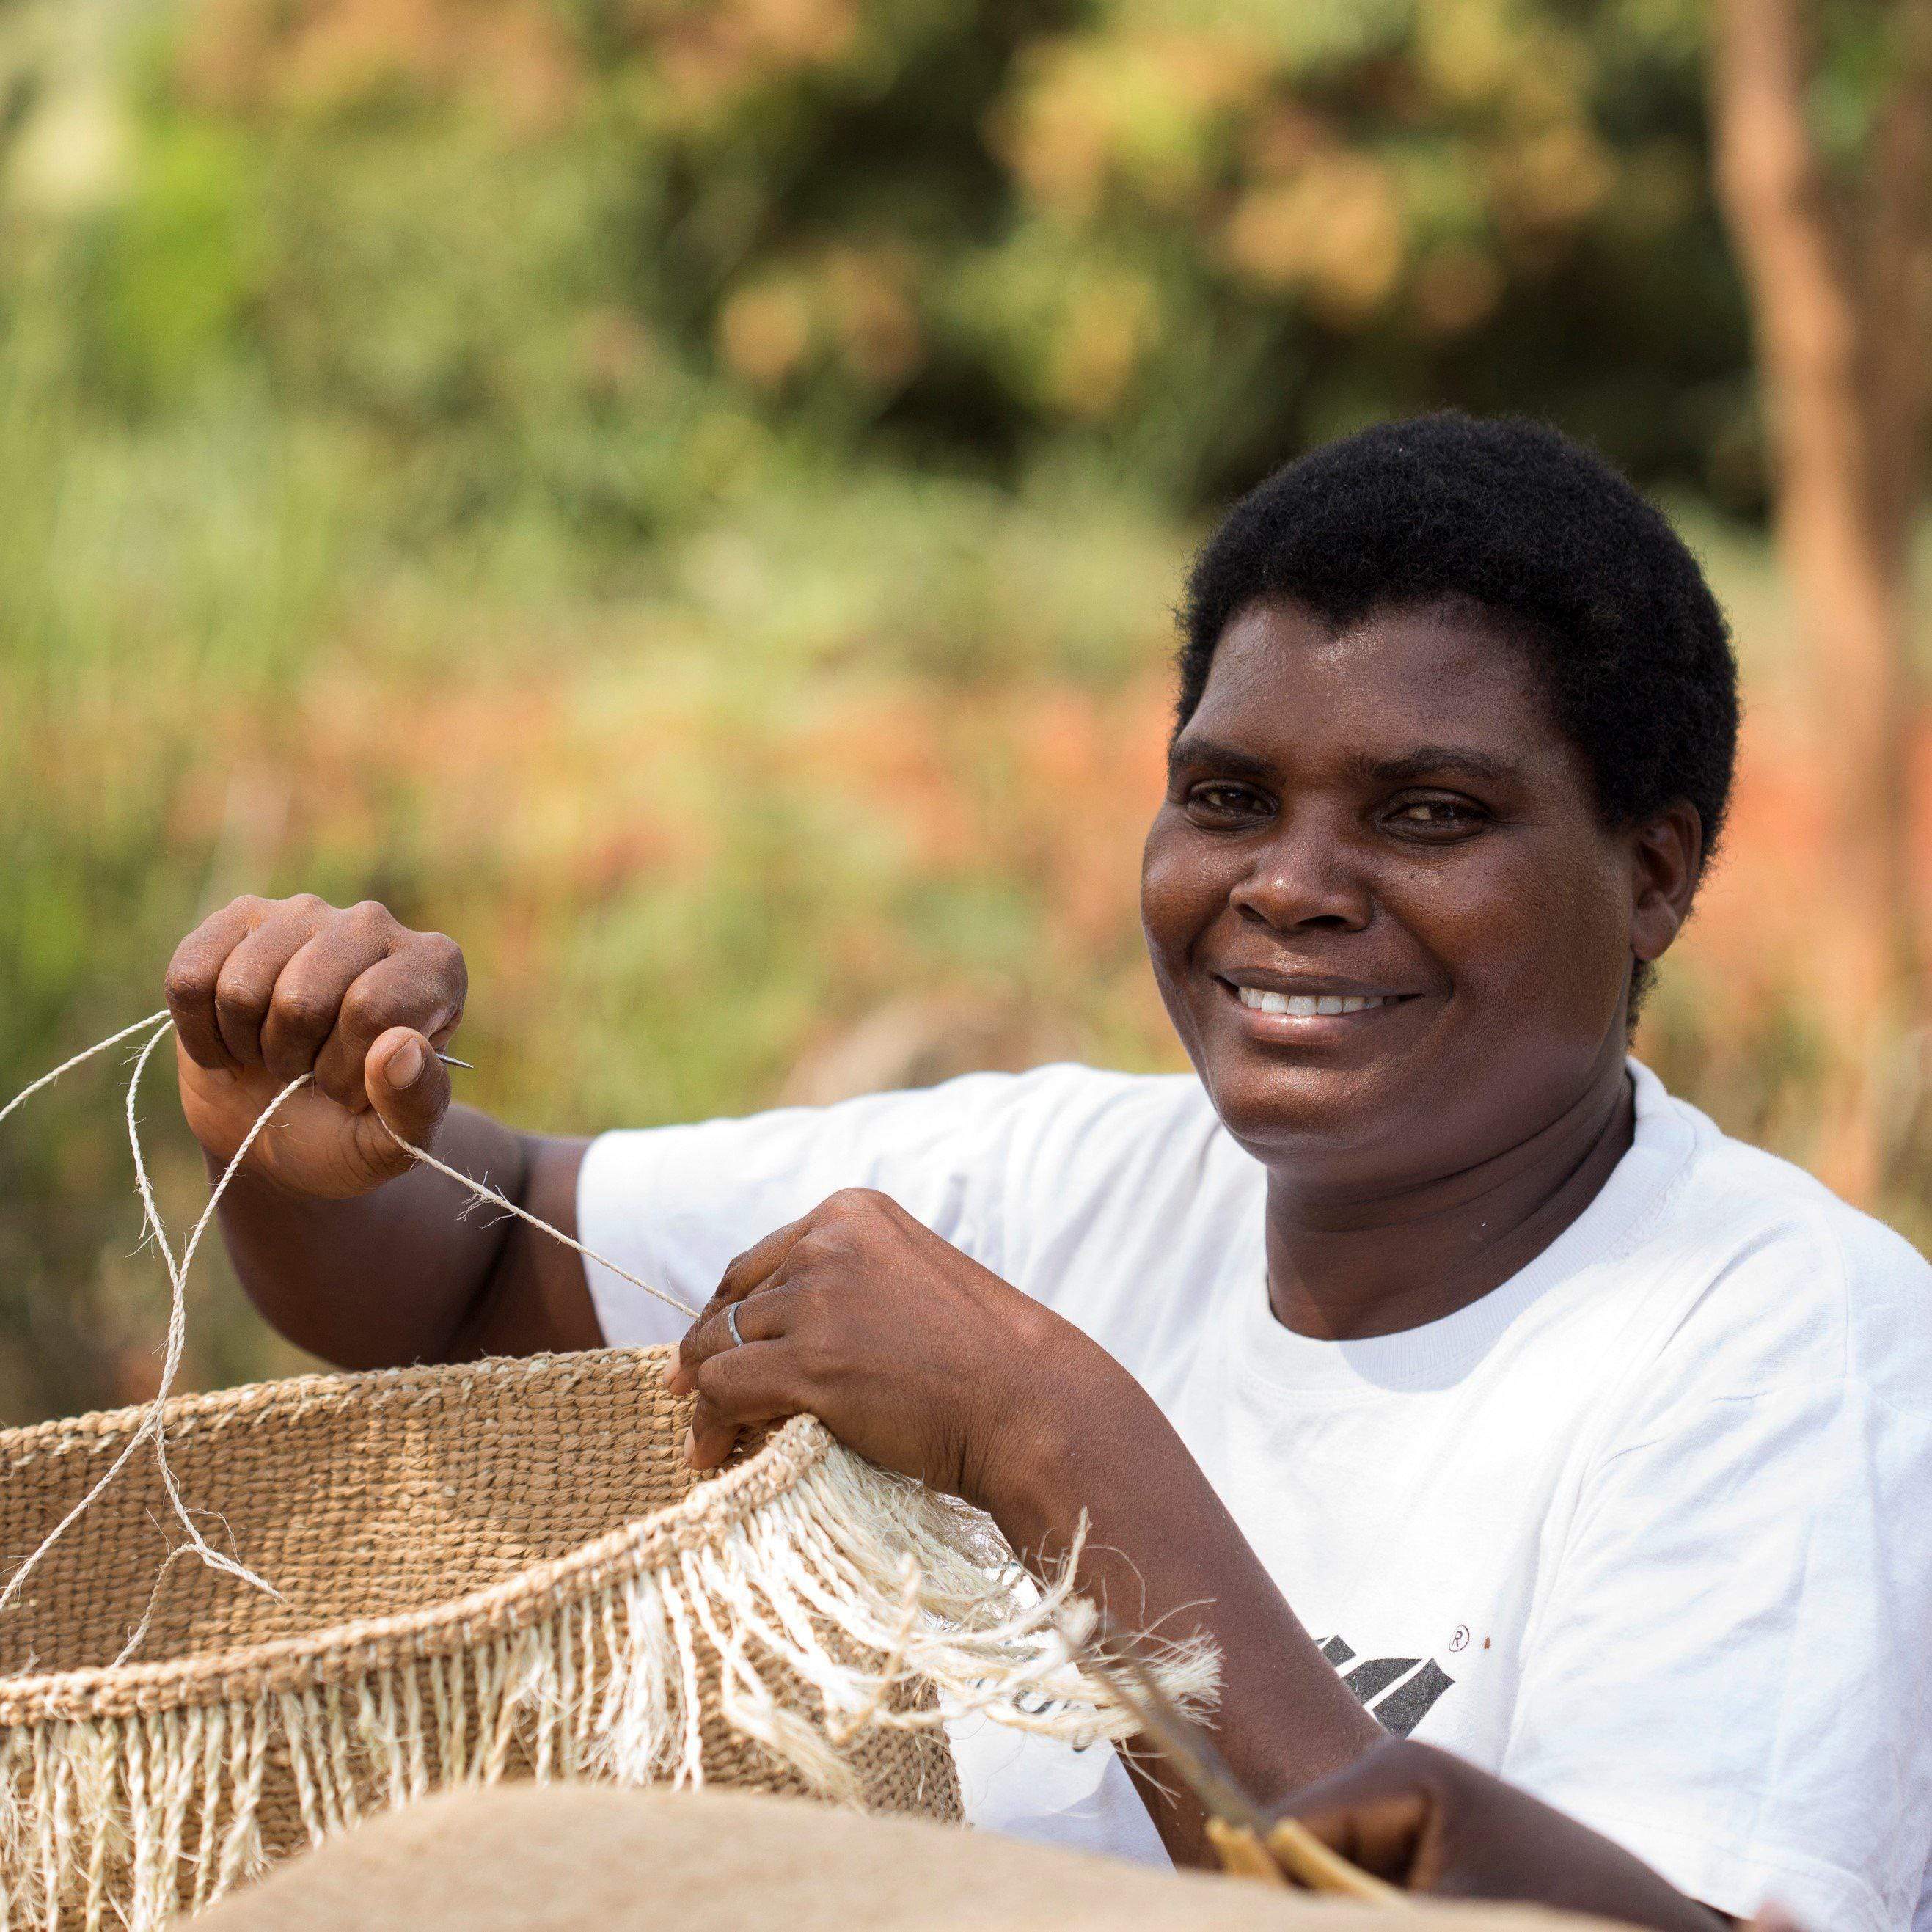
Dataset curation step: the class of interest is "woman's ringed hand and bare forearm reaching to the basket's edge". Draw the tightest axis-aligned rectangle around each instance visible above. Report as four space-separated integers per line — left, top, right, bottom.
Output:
676 1190 1383 1862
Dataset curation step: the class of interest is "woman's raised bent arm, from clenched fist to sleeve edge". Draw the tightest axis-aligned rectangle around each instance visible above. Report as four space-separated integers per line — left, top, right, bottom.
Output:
168 896 599 1368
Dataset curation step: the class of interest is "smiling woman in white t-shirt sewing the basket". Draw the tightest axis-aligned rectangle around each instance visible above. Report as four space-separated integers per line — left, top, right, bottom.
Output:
168 417 1932 1932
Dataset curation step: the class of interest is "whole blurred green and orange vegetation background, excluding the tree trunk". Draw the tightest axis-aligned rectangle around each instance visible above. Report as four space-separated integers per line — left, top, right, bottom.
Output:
0 0 1924 1416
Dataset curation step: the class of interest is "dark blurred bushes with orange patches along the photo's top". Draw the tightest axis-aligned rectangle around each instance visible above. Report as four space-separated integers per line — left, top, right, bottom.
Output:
0 0 1758 529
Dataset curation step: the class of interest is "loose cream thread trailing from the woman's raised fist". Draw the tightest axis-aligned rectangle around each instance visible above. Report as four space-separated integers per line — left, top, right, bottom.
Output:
0 1009 698 1622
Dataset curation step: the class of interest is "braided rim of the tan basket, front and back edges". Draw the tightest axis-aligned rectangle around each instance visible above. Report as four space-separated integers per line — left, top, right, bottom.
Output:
0 1349 837 1725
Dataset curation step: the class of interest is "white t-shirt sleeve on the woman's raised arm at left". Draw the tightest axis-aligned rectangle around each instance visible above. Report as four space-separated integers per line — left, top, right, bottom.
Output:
578 1066 1086 1344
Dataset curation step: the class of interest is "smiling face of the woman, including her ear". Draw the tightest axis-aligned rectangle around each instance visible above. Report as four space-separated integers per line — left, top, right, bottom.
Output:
1140 603 1697 1192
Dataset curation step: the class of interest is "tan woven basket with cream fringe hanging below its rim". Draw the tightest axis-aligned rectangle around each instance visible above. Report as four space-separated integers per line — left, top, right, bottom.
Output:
0 1349 1144 1932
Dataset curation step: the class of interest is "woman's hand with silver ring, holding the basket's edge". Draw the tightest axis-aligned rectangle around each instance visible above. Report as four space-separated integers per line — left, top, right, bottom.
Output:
670 1188 1124 1517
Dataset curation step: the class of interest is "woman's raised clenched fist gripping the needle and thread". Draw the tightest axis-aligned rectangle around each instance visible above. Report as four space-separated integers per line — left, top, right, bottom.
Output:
168 895 469 1200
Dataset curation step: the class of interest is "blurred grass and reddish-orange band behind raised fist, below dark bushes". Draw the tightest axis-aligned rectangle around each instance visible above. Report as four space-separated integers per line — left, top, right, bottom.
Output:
0 324 1186 1416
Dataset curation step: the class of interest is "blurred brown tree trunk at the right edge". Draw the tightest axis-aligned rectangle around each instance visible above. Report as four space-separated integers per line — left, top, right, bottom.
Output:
1712 0 1932 1194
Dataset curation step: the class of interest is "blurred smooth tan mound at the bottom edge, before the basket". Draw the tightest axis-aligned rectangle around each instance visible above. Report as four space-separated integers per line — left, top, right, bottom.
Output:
195 1785 1602 1932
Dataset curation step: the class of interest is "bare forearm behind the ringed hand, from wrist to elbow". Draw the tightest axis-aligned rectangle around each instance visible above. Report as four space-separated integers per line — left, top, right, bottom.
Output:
993 1364 1383 1865
